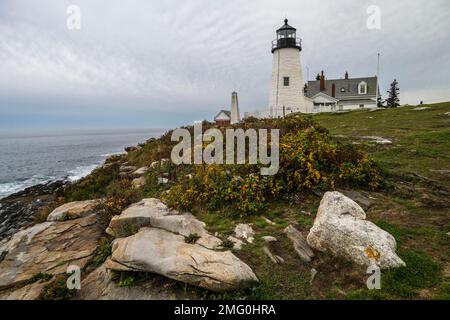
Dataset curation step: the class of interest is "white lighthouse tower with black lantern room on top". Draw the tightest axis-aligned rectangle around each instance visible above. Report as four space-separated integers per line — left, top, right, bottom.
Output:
269 19 309 118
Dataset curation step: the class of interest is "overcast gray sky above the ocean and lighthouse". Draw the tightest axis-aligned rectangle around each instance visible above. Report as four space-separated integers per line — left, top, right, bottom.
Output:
0 0 450 129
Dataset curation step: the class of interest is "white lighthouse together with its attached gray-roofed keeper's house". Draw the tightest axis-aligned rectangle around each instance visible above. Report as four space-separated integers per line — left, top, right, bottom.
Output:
245 19 378 118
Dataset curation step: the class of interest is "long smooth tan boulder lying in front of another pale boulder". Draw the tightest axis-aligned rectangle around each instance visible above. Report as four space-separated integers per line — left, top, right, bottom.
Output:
106 228 258 292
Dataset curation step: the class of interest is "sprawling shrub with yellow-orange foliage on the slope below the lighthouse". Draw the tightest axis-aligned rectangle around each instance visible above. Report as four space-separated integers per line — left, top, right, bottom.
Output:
164 116 382 216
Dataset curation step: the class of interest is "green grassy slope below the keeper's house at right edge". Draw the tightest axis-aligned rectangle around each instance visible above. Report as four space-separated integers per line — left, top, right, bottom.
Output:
313 102 450 187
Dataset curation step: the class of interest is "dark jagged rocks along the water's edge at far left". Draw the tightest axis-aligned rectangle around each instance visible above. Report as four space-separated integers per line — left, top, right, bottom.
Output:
0 180 71 240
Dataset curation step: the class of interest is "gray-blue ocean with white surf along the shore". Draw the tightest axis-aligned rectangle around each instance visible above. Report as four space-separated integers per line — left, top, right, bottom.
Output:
0 129 167 199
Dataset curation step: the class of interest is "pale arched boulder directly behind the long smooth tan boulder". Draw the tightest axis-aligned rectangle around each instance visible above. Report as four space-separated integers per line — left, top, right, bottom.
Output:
106 198 222 249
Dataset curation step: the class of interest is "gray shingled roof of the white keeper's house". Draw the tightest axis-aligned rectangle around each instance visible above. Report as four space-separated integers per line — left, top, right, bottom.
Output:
306 77 377 99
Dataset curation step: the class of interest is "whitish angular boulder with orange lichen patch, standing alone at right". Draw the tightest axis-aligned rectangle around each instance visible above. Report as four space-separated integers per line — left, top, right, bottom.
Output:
307 192 405 268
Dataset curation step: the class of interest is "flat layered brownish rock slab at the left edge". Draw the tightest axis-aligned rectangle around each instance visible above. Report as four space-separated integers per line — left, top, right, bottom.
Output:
0 214 103 289
